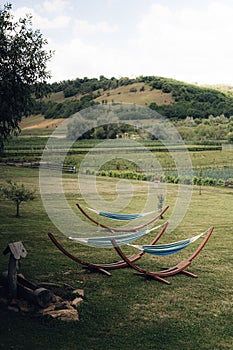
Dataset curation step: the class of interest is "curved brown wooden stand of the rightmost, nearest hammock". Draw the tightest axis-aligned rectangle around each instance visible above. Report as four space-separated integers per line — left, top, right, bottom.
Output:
112 227 214 284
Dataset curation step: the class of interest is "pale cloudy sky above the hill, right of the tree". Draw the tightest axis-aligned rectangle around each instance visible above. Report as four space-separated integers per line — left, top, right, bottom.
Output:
9 0 233 85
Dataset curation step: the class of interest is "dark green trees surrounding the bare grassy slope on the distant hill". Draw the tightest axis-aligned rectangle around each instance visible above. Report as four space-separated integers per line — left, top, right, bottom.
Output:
31 75 233 120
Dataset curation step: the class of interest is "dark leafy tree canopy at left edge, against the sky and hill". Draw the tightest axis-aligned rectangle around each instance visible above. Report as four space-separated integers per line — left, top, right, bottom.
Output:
0 4 52 149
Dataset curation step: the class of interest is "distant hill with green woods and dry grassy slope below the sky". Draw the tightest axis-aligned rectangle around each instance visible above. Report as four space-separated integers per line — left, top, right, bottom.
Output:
34 76 233 120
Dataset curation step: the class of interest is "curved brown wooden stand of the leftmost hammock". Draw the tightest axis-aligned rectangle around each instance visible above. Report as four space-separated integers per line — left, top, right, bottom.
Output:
48 222 168 276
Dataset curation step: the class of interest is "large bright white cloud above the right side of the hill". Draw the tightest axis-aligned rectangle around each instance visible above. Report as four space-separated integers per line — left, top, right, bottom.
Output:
135 2 233 83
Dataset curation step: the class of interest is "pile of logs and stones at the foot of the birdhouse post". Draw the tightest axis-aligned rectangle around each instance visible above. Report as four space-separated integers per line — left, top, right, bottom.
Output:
0 272 84 321
